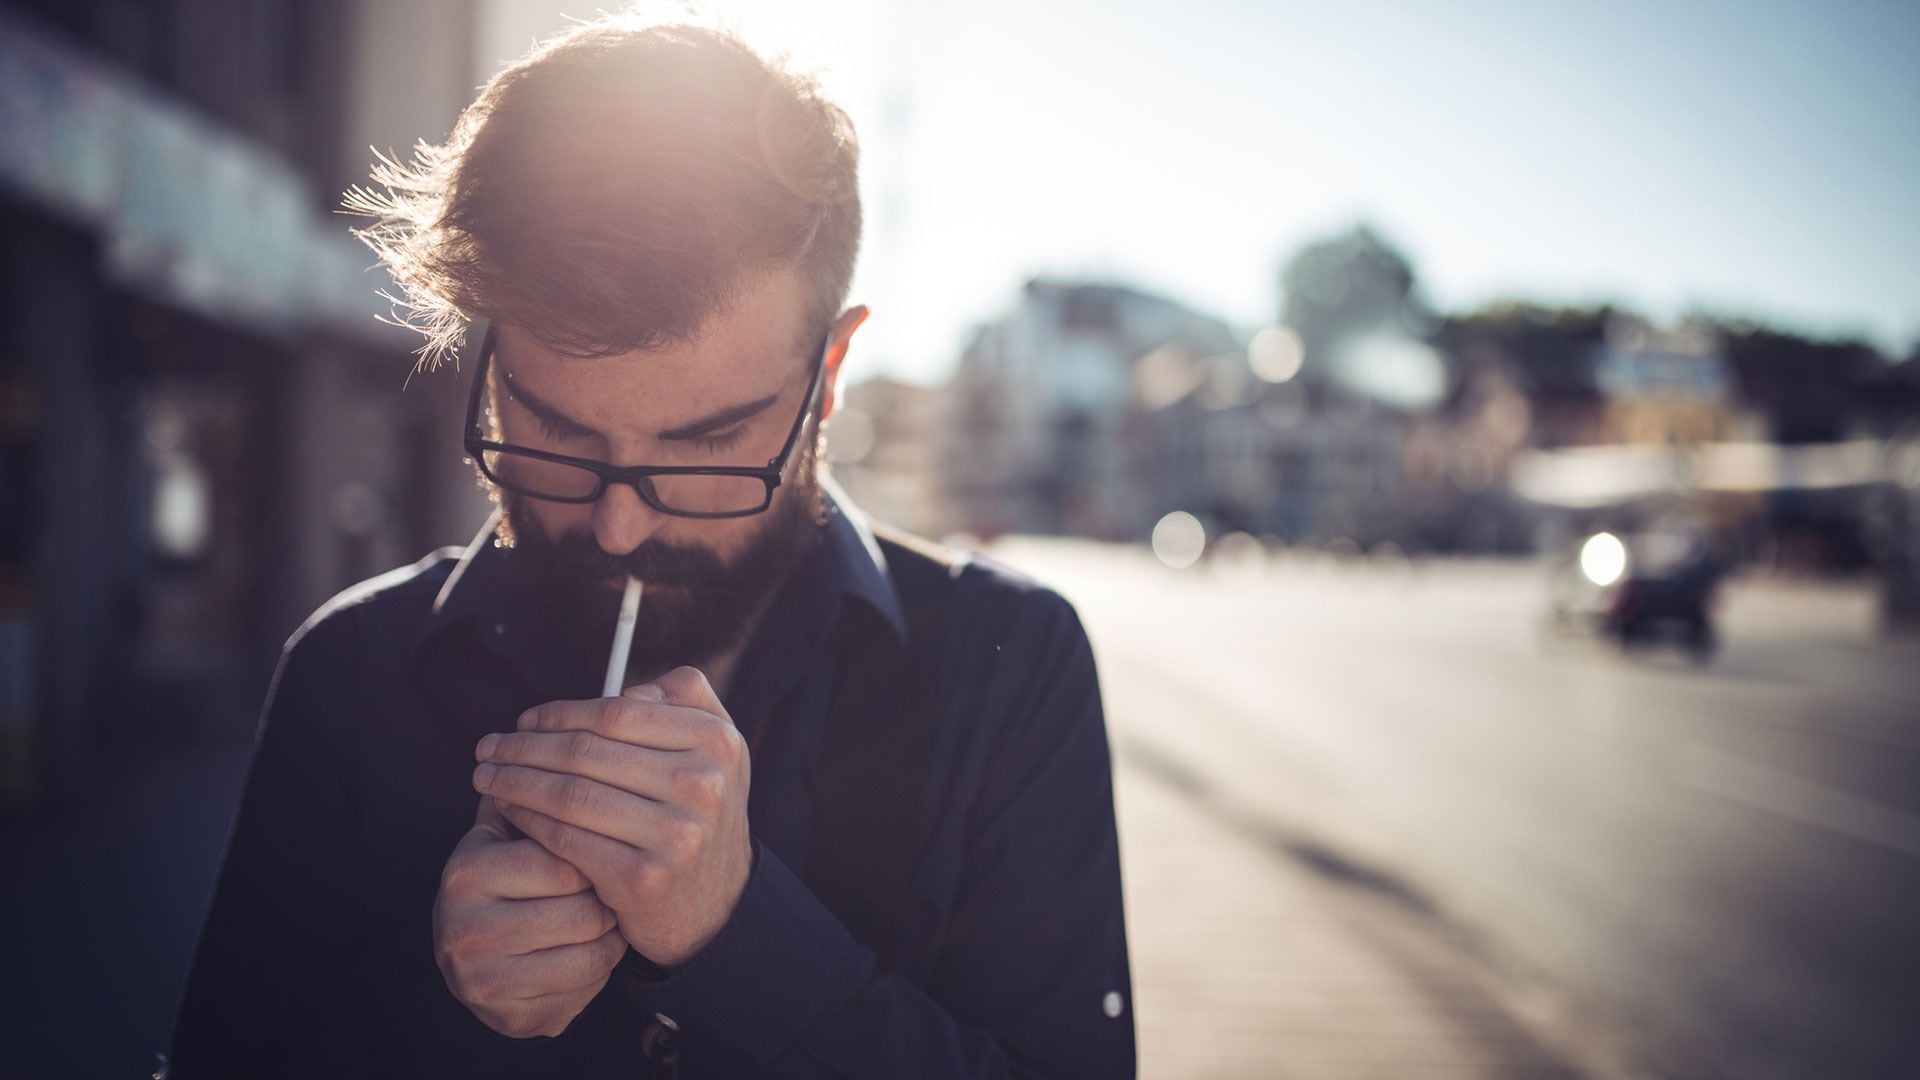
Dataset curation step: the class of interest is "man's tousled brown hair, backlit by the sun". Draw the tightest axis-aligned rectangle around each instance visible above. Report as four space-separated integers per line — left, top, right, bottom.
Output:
344 15 860 367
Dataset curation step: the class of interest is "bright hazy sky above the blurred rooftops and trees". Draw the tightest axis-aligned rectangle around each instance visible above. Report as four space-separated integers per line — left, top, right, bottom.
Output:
482 0 1920 382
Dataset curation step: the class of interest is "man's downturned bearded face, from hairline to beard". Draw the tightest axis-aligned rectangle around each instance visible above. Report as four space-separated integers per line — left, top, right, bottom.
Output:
493 265 858 675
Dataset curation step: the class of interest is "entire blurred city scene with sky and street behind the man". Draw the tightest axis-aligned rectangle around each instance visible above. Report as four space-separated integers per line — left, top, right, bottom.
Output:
0 0 1920 1078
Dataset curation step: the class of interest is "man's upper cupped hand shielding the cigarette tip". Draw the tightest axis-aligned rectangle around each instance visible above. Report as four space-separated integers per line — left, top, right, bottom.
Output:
474 667 753 969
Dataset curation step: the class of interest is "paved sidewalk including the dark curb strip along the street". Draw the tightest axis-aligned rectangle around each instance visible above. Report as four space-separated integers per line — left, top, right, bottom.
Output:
1102 667 1590 1080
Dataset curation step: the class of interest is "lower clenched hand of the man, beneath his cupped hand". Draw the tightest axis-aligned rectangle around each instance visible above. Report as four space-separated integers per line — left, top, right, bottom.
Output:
434 796 626 1038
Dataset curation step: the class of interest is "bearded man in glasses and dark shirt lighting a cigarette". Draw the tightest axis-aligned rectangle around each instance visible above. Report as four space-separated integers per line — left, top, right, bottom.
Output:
169 17 1135 1080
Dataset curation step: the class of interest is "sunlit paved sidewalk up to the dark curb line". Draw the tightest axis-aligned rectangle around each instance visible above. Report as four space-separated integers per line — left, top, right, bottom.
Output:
1117 737 1582 1078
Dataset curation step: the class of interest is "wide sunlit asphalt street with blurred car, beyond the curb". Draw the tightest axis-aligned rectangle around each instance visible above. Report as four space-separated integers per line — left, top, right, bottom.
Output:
993 540 1920 1076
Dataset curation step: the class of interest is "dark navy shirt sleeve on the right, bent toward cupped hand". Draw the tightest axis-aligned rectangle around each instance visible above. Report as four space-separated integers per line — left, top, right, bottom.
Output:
626 594 1135 1078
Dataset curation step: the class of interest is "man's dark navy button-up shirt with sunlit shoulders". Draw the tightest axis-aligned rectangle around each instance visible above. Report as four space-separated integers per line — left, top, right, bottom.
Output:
171 490 1135 1080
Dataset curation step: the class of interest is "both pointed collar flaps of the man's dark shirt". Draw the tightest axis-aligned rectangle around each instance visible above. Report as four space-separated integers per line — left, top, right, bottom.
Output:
422 471 906 642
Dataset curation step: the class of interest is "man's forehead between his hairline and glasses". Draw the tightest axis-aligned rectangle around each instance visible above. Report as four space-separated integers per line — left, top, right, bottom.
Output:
493 271 814 417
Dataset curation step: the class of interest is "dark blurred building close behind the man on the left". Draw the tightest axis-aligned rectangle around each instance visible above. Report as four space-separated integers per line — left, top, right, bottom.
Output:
0 0 495 805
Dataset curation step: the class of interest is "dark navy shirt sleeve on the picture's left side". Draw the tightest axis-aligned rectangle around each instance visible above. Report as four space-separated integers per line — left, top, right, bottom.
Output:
167 613 564 1080
